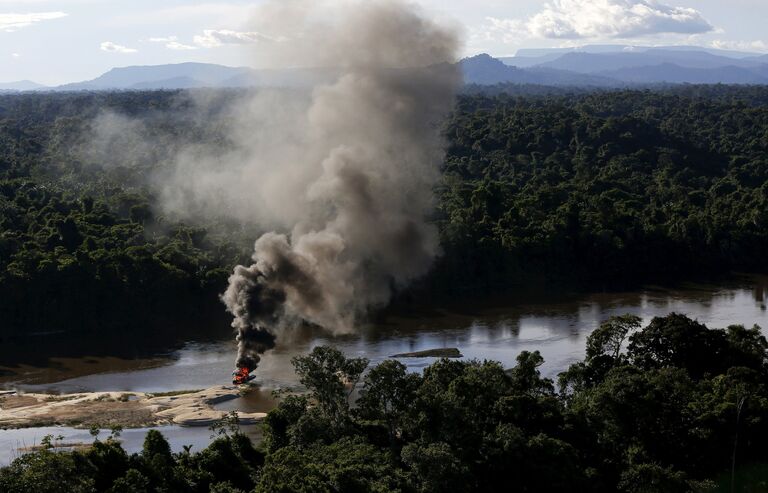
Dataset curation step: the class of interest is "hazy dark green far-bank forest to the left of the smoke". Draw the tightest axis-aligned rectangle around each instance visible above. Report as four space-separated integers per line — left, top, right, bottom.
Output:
0 92 252 337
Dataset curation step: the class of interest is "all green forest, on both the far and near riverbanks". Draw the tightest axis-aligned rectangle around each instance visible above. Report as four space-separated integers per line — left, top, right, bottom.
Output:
0 86 768 493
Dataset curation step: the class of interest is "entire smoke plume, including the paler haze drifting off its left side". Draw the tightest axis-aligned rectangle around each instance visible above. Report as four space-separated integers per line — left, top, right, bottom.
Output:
207 0 460 369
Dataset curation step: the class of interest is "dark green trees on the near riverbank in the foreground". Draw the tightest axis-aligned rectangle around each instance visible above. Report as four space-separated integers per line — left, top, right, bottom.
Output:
0 314 768 493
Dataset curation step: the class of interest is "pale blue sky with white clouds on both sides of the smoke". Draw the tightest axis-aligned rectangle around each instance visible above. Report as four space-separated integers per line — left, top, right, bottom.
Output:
0 0 768 85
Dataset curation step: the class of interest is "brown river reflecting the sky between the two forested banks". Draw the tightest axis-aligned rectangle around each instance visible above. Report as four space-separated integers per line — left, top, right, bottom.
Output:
0 275 768 462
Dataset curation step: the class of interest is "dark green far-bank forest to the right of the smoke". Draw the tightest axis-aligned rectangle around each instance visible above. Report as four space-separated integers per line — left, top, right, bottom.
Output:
436 87 768 291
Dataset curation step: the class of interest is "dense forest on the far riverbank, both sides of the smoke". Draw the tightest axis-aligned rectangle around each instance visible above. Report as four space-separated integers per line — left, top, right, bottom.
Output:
0 86 768 337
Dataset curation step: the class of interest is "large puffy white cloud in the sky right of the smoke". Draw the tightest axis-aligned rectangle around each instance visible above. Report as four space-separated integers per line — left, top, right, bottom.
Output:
527 0 714 39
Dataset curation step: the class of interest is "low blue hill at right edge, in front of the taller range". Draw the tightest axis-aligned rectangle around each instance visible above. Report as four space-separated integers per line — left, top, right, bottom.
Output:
601 63 768 84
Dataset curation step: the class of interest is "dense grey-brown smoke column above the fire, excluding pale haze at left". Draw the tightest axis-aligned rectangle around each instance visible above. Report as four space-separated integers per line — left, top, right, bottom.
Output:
222 0 460 370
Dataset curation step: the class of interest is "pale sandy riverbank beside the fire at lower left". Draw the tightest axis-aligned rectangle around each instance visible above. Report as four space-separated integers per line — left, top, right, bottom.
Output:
0 385 266 428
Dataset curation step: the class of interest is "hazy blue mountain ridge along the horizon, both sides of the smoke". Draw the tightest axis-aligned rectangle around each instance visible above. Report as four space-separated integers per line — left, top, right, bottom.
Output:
0 45 768 93
